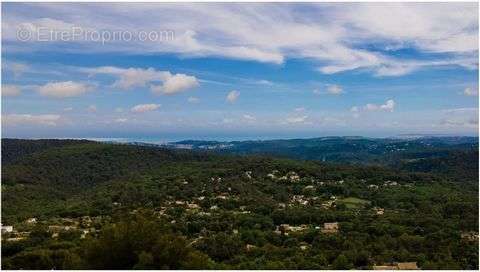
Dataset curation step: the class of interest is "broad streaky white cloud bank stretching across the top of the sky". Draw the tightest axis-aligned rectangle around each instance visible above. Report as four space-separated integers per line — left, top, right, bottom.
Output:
2 3 478 76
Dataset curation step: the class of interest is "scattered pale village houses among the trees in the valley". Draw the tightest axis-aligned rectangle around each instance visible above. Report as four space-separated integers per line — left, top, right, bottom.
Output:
1 170 478 270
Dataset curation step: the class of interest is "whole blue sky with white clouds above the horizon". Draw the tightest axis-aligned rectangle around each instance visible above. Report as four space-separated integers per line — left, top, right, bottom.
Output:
1 3 479 140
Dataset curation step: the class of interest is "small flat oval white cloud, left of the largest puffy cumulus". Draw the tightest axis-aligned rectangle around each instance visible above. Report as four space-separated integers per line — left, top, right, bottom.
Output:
37 81 92 98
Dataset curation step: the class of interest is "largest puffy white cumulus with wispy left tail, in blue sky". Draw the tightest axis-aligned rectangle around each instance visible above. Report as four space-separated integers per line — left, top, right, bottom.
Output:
81 66 199 95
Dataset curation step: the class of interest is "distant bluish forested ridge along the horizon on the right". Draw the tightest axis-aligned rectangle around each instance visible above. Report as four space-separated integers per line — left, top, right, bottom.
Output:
171 137 478 164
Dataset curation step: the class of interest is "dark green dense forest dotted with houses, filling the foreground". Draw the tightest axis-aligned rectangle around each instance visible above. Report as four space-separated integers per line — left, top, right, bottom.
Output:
1 139 479 269
